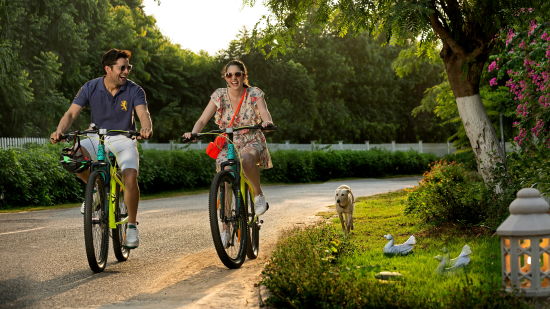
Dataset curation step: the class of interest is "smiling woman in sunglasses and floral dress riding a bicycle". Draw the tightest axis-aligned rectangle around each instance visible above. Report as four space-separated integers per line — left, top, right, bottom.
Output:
183 60 273 216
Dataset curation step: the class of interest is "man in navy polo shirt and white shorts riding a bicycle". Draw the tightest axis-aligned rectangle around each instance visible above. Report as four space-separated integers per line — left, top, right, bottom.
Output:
50 49 153 249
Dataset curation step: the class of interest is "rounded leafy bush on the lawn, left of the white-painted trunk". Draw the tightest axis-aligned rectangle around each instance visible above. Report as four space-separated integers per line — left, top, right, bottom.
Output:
405 161 487 225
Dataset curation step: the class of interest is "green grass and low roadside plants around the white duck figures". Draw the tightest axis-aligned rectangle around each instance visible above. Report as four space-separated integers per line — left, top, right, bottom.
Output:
262 191 527 308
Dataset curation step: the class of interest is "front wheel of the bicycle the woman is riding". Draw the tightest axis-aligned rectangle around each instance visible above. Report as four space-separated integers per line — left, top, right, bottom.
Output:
208 170 248 269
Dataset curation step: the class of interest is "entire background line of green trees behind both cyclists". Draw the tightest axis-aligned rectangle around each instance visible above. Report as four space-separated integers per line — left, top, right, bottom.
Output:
0 0 456 143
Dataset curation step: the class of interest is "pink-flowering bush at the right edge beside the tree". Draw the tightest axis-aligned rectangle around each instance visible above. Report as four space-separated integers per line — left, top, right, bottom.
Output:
494 20 550 150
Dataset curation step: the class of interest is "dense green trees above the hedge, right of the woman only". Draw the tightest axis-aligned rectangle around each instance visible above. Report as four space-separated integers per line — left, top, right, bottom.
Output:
223 31 450 143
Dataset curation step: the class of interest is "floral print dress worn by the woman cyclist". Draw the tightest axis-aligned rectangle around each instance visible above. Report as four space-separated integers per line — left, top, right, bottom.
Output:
210 87 273 169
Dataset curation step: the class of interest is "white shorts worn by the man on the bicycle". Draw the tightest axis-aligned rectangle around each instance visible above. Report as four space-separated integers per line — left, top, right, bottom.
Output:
80 134 139 171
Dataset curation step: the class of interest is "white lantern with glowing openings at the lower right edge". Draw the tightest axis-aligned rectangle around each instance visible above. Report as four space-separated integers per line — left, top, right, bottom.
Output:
497 188 550 296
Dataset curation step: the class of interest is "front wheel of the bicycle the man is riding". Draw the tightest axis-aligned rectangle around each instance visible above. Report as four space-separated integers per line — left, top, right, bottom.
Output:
84 171 109 273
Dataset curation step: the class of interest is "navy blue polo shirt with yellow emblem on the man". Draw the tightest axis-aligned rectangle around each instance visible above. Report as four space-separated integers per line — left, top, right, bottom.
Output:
73 77 147 130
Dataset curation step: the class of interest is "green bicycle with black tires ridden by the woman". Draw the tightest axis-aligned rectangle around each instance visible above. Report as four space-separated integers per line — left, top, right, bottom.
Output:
183 125 276 269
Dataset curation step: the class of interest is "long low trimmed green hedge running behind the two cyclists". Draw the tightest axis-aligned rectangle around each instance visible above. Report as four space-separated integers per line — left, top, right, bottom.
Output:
0 145 436 208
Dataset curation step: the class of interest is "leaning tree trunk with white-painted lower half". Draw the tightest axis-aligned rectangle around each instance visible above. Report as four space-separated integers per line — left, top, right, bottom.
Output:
441 44 505 185
